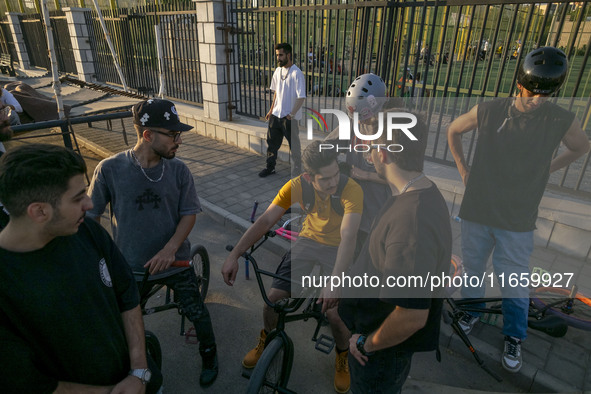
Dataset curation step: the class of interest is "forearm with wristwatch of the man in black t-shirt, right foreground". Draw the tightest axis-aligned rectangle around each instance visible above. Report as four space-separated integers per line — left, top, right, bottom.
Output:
349 306 429 365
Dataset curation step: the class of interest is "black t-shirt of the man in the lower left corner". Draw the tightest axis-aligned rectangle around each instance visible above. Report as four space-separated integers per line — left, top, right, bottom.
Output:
0 219 139 393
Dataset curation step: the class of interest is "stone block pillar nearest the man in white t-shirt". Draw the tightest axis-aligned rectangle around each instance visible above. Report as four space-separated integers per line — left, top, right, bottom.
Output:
193 0 240 120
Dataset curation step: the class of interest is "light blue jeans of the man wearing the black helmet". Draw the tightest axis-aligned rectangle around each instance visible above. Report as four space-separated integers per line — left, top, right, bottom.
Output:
462 220 534 340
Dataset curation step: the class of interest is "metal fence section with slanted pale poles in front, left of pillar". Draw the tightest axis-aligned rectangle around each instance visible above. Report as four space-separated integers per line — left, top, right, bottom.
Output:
86 3 203 103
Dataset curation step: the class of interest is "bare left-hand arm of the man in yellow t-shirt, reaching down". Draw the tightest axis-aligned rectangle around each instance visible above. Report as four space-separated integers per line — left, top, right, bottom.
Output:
222 204 286 286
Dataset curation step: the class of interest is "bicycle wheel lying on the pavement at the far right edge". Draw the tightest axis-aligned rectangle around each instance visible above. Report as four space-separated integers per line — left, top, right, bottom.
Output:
531 287 591 331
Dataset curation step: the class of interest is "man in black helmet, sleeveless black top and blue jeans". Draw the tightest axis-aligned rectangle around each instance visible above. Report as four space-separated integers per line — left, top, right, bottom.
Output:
447 47 589 372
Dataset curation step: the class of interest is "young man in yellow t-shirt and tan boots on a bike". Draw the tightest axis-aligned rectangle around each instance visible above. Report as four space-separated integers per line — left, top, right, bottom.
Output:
222 141 363 393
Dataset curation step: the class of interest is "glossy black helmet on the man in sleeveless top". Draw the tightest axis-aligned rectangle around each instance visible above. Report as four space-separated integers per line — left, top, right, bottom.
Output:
517 47 568 94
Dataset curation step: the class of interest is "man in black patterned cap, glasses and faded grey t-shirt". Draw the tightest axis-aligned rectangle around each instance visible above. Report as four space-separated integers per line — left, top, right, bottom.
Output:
88 99 218 387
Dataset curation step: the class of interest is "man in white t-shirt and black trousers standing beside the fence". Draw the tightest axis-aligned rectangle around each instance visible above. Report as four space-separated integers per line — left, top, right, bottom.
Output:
259 43 306 178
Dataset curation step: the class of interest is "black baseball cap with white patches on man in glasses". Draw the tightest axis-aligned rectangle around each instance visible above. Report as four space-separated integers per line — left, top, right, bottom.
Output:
131 99 193 131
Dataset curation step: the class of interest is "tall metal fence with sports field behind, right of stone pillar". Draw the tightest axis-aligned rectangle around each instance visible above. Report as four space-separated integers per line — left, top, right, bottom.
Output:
234 0 591 192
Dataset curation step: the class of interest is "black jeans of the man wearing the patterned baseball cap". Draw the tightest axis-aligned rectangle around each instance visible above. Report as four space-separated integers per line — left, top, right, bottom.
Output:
144 269 215 350
